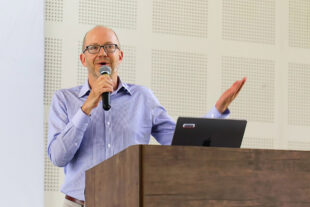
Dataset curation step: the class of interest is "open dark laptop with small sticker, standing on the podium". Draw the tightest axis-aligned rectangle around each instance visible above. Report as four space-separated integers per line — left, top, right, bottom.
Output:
171 117 247 148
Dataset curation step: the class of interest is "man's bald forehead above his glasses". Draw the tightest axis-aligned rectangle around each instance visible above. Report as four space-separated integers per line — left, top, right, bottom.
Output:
85 27 119 45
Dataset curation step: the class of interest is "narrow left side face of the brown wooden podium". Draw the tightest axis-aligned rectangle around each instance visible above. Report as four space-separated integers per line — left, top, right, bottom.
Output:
85 145 141 207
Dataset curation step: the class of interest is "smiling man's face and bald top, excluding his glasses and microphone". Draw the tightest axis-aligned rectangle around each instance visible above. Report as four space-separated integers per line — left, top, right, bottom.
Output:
80 27 123 78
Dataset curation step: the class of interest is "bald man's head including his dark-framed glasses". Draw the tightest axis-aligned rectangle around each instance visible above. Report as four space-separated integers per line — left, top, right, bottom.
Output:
80 26 123 79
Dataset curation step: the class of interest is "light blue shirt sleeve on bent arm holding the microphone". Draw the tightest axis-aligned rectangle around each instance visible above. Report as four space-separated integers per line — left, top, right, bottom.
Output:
47 91 90 167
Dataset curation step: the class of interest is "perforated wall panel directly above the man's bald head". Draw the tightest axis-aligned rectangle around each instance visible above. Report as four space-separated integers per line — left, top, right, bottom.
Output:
79 0 138 29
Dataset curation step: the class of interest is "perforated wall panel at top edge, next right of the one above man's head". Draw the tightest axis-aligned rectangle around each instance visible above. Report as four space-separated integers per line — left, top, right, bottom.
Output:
152 0 208 38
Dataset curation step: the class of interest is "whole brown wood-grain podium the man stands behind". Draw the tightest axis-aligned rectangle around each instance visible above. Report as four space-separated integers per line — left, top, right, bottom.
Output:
85 145 310 207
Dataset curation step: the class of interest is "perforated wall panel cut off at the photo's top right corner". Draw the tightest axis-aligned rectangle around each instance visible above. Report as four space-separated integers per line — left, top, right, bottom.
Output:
289 0 310 48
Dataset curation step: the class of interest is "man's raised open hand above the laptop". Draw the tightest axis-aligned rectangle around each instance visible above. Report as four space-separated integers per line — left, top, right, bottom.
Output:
215 77 246 114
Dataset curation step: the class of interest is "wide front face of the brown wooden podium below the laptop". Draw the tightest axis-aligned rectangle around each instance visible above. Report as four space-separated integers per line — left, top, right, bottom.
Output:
143 146 310 207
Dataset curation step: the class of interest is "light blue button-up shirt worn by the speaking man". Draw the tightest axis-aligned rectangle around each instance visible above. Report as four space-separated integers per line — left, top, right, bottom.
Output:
48 79 229 200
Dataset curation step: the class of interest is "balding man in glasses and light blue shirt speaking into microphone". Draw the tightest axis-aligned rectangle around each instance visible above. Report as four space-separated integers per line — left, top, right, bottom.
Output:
48 26 245 206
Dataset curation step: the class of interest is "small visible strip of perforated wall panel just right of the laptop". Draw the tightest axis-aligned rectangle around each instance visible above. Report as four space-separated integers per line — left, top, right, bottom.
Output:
241 137 275 149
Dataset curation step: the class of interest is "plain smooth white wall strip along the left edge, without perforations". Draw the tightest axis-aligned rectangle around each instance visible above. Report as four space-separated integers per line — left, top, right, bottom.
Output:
0 0 44 207
